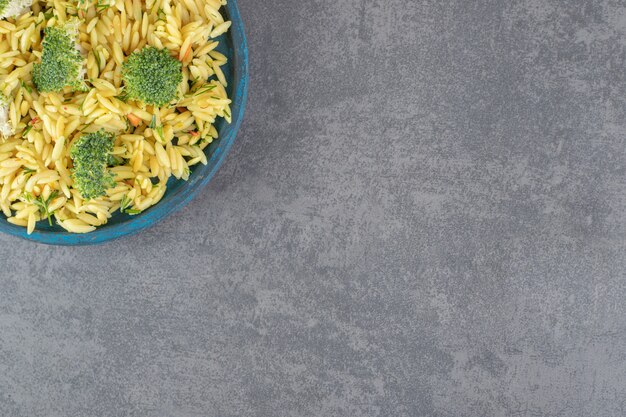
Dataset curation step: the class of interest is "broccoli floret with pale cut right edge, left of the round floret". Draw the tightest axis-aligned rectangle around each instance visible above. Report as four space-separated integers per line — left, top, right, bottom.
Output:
33 23 86 92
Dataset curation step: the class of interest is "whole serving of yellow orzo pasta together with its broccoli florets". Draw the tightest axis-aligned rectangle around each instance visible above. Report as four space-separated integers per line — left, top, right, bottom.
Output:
0 0 231 233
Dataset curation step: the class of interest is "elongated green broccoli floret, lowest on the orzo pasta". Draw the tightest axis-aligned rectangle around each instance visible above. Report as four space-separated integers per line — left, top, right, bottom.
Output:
70 130 115 200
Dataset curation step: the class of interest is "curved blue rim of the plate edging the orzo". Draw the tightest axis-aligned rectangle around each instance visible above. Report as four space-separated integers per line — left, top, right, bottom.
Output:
0 0 249 246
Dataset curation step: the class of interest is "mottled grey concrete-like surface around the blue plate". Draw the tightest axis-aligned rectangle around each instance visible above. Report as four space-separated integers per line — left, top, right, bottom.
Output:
0 0 626 417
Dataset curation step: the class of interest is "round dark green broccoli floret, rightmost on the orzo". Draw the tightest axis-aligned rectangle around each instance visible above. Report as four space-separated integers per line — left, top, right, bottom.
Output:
122 46 183 106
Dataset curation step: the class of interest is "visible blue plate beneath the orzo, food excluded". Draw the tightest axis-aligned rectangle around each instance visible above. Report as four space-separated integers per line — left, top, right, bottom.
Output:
0 0 249 246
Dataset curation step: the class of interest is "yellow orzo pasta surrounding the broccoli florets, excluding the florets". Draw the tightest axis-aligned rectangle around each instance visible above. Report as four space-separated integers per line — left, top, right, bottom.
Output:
0 0 231 234
